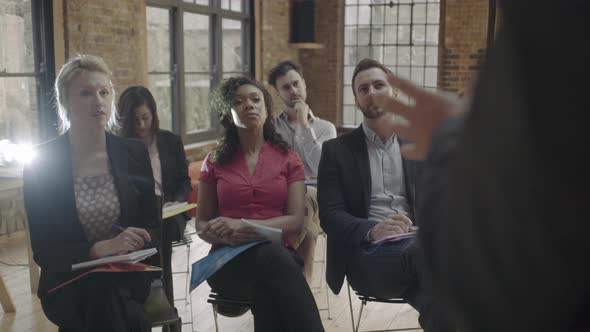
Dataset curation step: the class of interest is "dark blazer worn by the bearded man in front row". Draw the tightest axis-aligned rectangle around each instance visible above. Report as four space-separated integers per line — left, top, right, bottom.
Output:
318 126 418 294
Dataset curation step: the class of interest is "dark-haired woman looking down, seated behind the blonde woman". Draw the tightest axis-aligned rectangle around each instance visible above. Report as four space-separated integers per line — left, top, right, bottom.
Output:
118 85 191 299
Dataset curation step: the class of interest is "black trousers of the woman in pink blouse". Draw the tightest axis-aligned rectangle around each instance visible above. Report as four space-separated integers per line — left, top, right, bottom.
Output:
207 243 324 332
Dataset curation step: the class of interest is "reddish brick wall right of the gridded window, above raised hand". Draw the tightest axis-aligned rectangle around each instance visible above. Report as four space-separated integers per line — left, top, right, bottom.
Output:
438 0 489 92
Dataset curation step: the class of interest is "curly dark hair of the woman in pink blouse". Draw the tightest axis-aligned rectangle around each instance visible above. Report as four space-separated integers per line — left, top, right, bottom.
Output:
210 76 289 165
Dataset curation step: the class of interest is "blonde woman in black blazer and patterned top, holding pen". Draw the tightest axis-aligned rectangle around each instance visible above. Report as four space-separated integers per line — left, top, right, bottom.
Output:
24 55 158 331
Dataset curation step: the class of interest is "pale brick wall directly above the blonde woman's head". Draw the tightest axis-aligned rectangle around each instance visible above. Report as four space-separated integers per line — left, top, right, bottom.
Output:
63 0 147 93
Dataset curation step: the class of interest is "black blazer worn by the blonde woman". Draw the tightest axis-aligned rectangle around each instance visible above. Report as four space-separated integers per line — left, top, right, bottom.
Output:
24 133 160 297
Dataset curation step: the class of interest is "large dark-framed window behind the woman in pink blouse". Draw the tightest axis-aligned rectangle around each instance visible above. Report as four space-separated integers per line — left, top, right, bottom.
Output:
146 0 253 143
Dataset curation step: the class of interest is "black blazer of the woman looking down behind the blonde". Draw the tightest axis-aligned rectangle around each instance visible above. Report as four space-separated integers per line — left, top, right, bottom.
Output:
156 130 192 202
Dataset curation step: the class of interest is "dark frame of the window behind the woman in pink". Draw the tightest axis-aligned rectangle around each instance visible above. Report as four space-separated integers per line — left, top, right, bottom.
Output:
146 0 255 144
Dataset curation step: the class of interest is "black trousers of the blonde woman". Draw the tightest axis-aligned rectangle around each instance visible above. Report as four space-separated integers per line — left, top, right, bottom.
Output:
41 272 151 332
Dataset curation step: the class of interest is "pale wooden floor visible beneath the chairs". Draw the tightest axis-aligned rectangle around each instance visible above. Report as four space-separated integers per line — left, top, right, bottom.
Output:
0 226 421 332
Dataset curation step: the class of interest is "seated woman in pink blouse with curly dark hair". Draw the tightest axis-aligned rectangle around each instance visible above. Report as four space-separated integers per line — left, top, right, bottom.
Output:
197 77 324 331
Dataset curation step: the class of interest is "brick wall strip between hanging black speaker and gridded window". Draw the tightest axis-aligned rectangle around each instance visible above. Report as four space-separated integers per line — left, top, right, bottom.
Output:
300 0 344 125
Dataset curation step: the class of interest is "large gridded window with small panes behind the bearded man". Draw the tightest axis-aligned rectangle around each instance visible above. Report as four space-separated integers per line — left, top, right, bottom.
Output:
342 0 440 126
